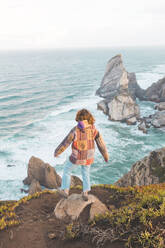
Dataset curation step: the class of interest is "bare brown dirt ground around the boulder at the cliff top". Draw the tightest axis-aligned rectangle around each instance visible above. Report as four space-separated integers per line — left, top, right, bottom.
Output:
0 188 124 248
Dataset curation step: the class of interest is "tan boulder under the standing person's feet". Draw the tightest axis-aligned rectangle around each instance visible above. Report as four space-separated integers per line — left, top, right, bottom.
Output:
54 194 108 220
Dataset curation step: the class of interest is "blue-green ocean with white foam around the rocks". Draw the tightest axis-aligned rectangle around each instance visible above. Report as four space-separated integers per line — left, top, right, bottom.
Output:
0 47 165 200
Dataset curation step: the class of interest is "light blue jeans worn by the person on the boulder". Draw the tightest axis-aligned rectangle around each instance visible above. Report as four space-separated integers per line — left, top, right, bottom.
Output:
61 159 91 191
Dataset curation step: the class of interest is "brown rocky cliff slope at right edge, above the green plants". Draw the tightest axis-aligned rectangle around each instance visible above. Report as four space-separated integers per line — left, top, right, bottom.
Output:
115 147 165 187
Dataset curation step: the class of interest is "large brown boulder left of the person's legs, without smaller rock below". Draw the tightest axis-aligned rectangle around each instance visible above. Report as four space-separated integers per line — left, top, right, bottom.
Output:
23 156 61 189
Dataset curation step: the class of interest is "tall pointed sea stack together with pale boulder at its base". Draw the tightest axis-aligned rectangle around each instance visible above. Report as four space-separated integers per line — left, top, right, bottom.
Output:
96 55 144 124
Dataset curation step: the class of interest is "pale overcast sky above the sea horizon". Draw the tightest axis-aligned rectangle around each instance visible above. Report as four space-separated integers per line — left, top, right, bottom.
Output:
0 0 165 50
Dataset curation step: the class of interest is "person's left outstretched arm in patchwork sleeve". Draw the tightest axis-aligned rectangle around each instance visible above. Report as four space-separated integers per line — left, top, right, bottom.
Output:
54 128 75 157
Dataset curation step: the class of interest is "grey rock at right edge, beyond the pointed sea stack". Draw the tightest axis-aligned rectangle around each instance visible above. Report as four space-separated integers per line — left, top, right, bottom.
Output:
144 77 165 102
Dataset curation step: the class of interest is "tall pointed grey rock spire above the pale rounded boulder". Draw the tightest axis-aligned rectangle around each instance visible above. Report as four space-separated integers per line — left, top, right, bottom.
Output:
96 54 143 100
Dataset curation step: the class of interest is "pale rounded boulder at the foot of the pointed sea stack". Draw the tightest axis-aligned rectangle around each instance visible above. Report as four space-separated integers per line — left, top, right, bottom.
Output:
108 93 140 121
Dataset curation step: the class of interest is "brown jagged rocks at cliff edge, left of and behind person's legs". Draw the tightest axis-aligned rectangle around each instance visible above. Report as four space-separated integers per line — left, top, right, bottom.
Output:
22 156 82 194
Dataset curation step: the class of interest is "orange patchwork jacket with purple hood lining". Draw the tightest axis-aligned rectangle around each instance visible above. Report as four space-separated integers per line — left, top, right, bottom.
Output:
54 120 109 165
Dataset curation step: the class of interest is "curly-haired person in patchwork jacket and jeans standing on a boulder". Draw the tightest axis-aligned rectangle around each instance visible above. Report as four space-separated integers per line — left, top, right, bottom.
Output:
54 109 109 201
